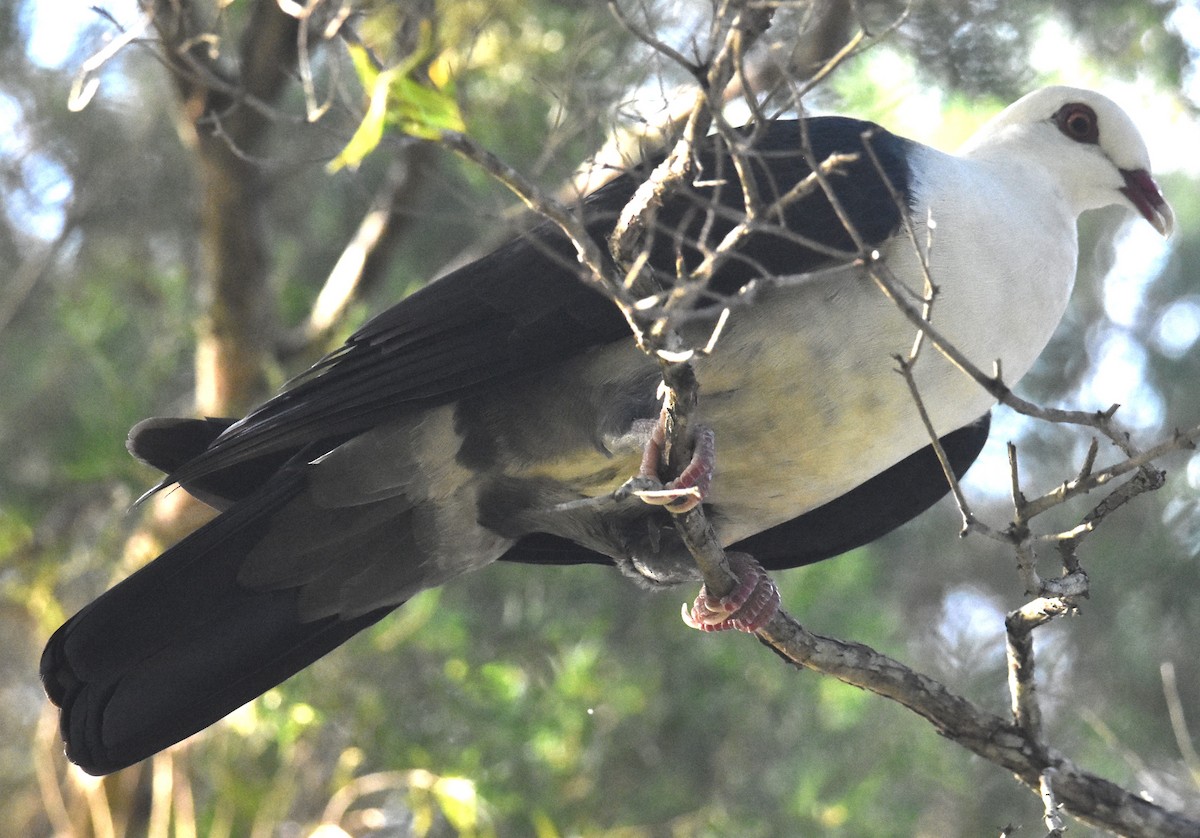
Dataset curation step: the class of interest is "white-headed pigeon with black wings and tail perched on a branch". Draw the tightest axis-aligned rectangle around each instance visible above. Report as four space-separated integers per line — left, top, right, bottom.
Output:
41 86 1174 774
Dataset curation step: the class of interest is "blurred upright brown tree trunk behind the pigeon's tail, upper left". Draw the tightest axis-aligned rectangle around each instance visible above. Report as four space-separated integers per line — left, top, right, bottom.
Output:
151 0 299 415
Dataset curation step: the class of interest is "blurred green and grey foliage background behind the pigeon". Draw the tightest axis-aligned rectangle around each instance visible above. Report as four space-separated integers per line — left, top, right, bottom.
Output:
0 0 1200 838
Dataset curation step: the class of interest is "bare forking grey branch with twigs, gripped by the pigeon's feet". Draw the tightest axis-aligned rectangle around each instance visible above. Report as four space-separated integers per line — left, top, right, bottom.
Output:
434 4 1200 836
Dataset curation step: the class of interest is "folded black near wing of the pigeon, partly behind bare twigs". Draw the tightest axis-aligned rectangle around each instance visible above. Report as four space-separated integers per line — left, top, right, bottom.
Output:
154 116 908 497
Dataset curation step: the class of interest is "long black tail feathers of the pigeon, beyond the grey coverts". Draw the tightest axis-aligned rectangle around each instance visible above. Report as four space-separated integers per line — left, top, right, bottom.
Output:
41 475 395 774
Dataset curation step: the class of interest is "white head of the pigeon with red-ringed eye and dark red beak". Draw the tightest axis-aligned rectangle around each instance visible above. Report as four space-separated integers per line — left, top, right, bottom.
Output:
959 86 1175 235
